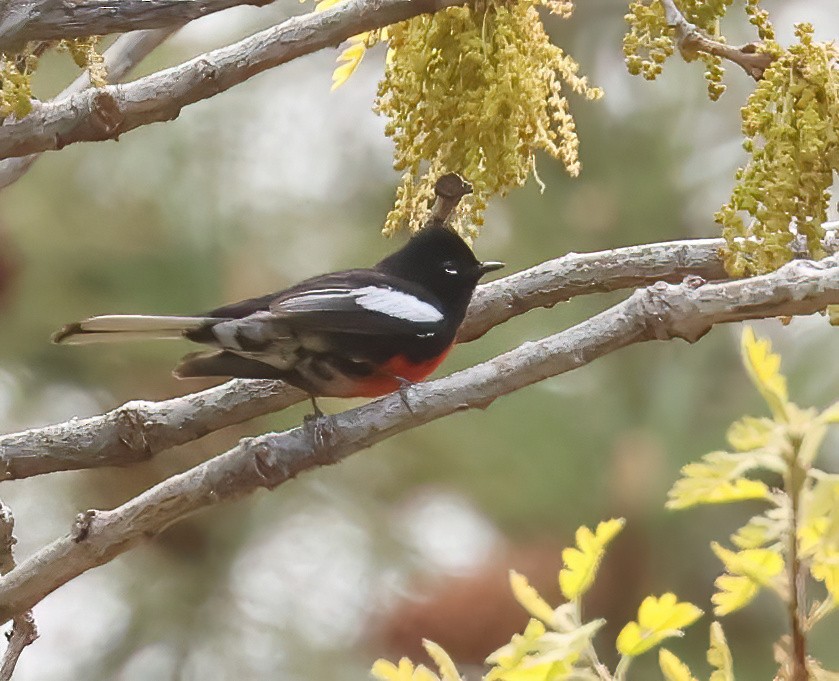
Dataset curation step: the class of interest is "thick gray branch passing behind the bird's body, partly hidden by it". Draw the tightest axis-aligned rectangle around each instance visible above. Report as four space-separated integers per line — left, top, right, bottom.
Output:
0 239 726 480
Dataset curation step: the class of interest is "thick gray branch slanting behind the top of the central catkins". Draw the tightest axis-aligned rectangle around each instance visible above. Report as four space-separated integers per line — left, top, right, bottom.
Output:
0 0 465 158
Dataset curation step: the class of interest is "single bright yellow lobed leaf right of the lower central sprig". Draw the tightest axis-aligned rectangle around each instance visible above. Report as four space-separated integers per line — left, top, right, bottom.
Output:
616 593 702 657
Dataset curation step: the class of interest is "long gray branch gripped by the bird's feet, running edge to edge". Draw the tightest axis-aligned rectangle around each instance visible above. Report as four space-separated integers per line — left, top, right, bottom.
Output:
0 256 839 621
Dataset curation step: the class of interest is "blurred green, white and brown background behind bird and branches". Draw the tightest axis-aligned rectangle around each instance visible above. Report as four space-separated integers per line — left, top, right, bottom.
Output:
0 0 839 681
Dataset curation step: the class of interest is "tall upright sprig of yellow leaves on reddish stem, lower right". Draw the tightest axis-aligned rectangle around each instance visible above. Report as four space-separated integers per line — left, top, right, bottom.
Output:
667 328 839 679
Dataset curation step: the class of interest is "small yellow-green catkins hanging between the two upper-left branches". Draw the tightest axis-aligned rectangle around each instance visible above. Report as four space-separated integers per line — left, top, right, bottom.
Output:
0 36 107 120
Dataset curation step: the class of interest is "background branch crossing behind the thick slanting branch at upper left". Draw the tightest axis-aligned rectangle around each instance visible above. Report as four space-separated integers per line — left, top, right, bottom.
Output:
0 28 178 189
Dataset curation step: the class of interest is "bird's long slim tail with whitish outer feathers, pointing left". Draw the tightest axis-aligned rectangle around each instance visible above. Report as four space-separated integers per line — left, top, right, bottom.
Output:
52 314 219 345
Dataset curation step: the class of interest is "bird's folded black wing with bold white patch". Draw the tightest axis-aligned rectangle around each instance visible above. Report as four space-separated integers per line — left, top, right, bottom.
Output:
269 270 445 334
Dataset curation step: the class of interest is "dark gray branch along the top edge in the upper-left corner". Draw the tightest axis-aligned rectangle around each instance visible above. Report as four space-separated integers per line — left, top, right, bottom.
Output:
0 0 266 53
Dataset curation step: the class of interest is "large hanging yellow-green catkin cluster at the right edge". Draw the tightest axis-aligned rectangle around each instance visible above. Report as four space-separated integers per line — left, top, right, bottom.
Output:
716 24 839 276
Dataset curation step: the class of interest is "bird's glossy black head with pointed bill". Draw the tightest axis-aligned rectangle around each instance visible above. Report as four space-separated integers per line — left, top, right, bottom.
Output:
375 222 504 324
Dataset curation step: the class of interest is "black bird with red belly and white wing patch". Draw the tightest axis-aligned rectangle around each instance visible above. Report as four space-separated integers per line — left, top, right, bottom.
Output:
53 174 503 410
